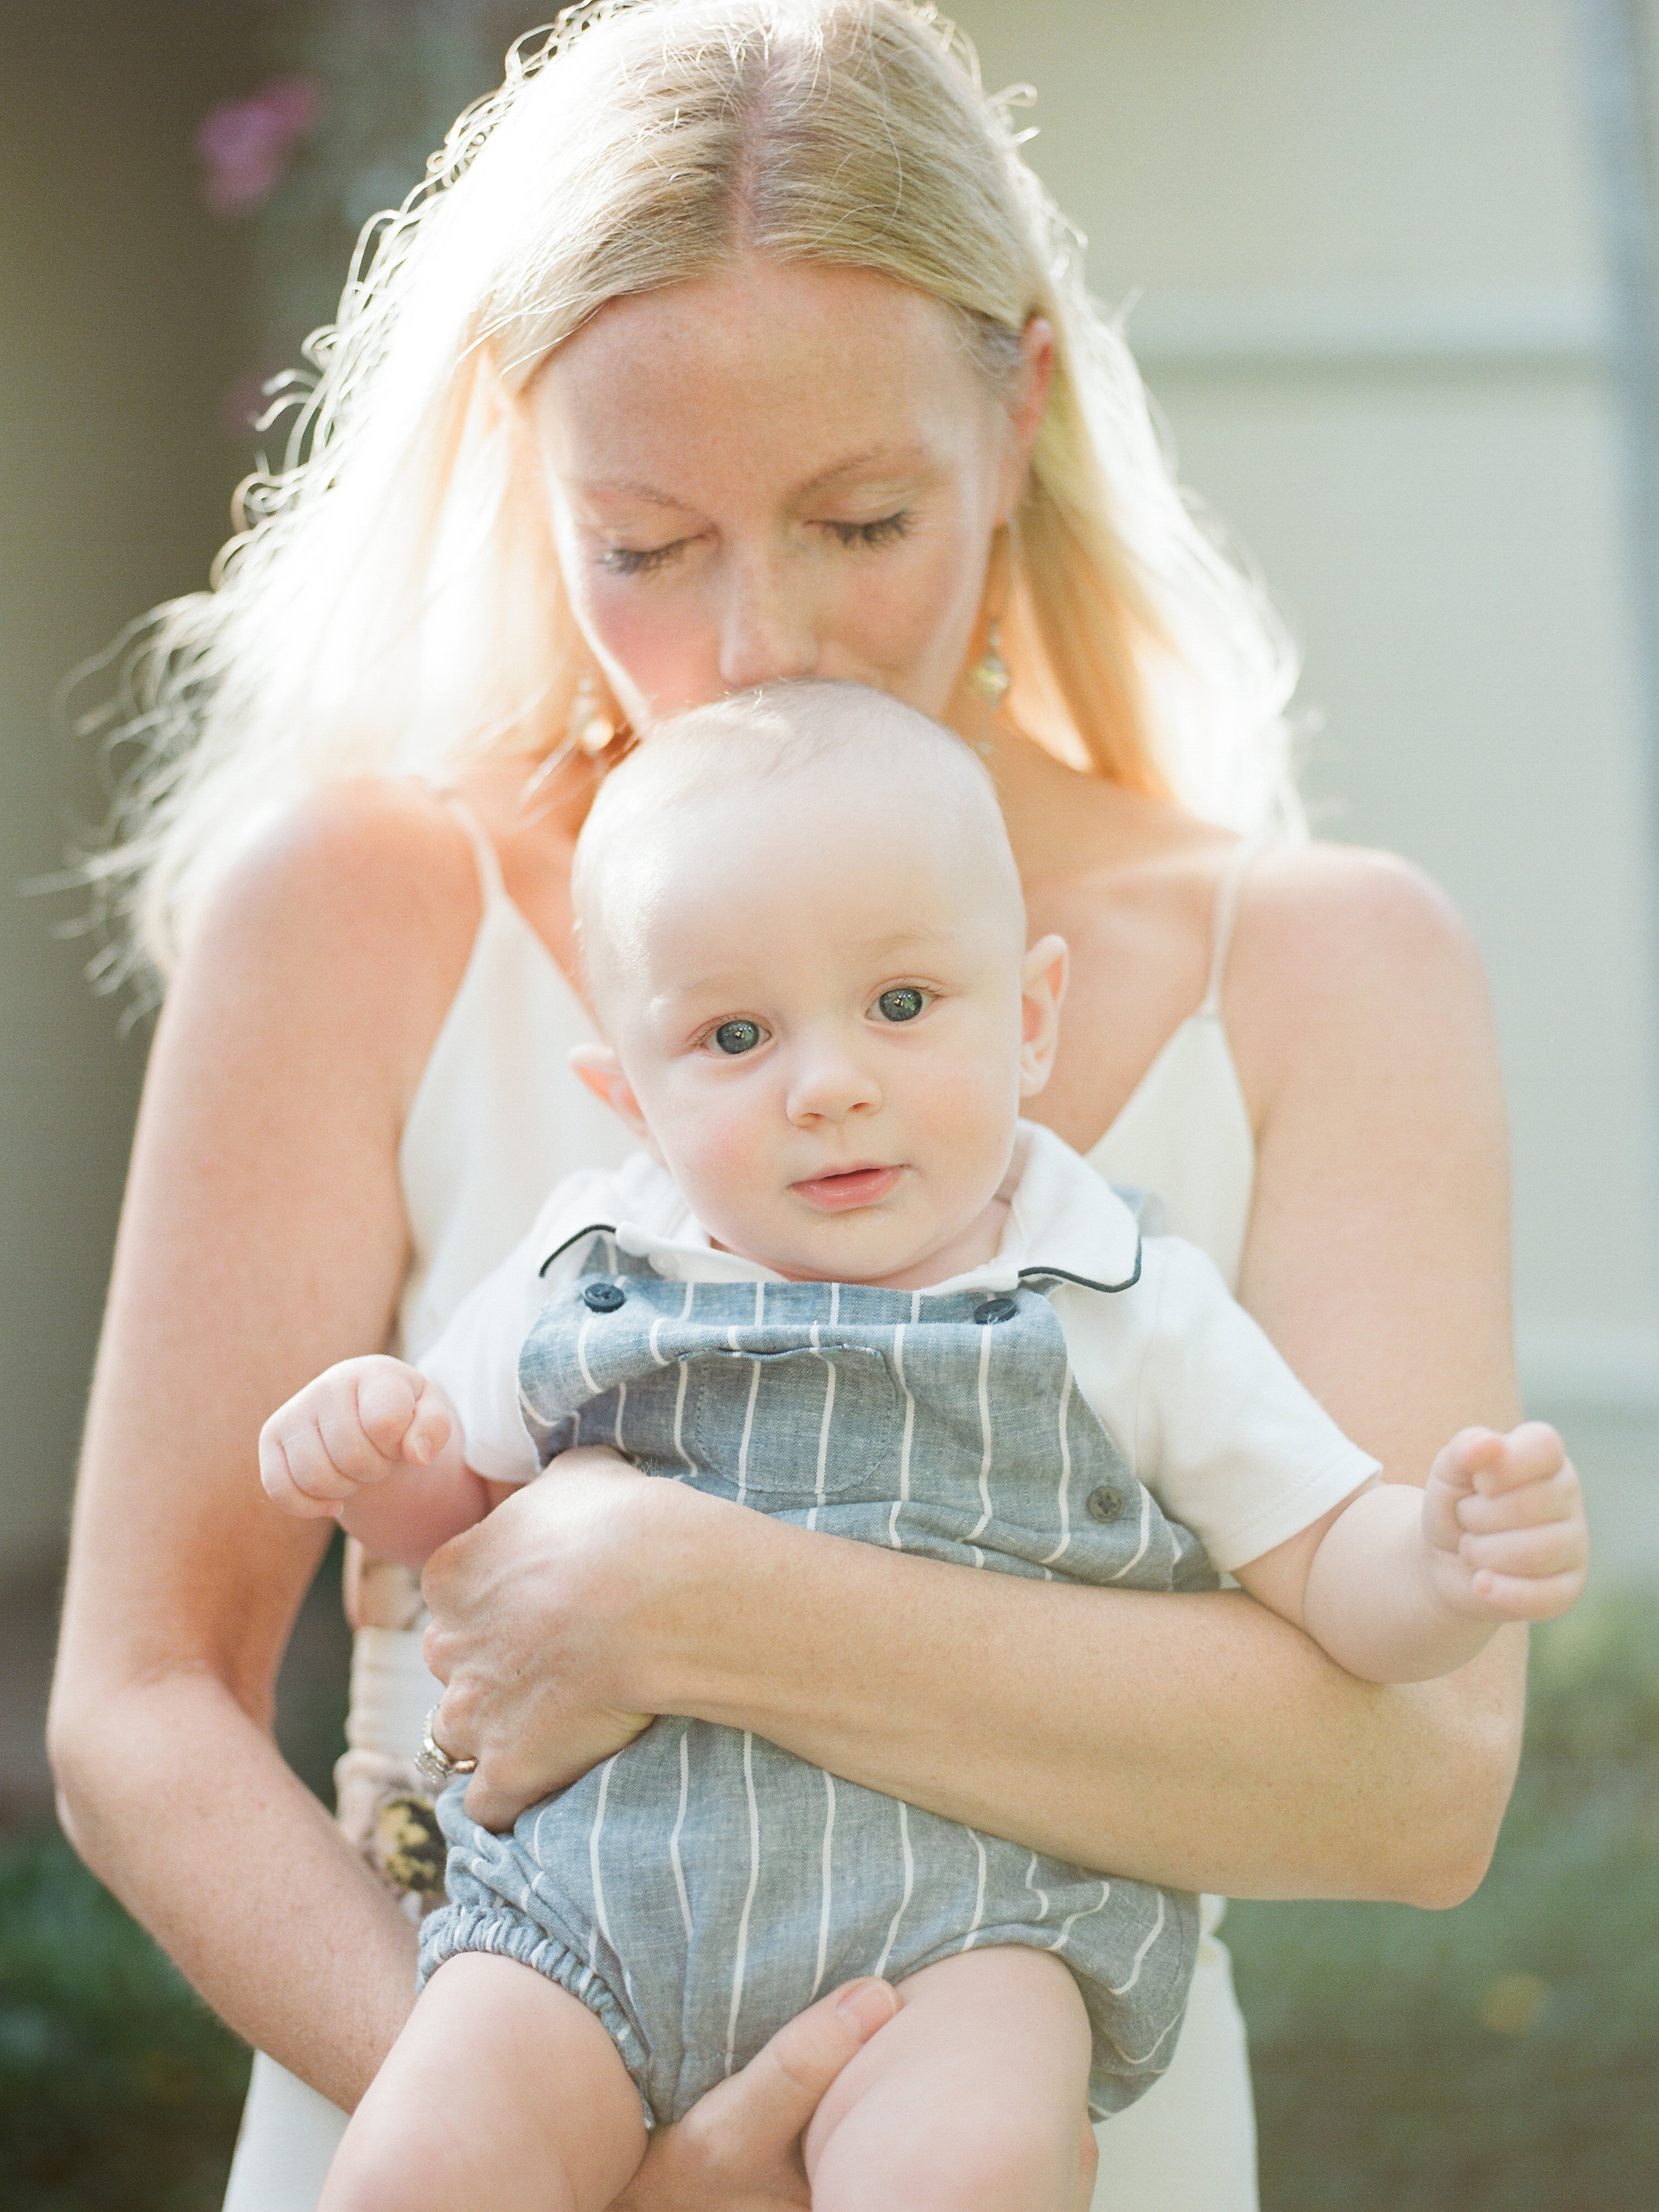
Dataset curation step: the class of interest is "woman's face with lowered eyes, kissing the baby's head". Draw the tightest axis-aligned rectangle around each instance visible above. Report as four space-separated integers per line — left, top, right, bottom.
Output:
531 261 1050 728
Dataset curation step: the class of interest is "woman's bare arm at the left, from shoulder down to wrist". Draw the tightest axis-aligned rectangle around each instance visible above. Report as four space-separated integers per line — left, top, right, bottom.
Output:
48 785 478 2108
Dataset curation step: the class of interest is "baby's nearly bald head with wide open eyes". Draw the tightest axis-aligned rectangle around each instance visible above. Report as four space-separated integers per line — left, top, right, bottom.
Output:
573 682 1066 1288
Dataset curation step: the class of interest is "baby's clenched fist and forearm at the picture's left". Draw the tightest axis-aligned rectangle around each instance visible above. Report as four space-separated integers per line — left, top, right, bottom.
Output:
259 1354 491 1568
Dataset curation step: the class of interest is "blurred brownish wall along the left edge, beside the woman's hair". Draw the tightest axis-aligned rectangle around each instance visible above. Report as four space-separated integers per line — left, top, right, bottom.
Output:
0 0 261 1573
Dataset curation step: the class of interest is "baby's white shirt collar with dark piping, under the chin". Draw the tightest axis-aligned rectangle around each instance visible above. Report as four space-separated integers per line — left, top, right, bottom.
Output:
542 1122 1141 1291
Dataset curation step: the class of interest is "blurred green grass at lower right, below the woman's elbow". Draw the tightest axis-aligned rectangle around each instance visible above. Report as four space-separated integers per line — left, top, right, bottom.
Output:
1228 1597 1659 2212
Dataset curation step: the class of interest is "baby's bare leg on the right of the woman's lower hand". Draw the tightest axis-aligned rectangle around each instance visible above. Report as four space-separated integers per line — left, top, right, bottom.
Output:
805 1945 1095 2212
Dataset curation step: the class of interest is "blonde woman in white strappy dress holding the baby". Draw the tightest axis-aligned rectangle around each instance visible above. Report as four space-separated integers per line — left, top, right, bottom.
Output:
53 0 1520 2212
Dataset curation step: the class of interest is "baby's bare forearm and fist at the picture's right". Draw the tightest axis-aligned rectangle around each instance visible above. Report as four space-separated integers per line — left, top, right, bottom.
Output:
1234 1420 1588 1681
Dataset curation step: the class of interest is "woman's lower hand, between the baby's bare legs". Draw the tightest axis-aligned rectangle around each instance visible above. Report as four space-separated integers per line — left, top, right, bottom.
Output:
611 1982 898 2212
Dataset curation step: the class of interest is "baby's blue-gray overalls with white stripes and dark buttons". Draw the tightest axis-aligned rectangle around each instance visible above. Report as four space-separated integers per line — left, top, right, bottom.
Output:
420 1230 1214 2121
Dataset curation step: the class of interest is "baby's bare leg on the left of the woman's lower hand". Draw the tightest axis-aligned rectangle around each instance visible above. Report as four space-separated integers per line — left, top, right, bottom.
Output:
319 1951 646 2212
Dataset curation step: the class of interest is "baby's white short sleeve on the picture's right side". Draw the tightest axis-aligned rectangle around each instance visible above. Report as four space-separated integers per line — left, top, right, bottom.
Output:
1135 1236 1382 1573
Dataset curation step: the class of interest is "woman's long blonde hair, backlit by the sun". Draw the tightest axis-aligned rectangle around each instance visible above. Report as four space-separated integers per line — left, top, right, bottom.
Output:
93 0 1294 974
